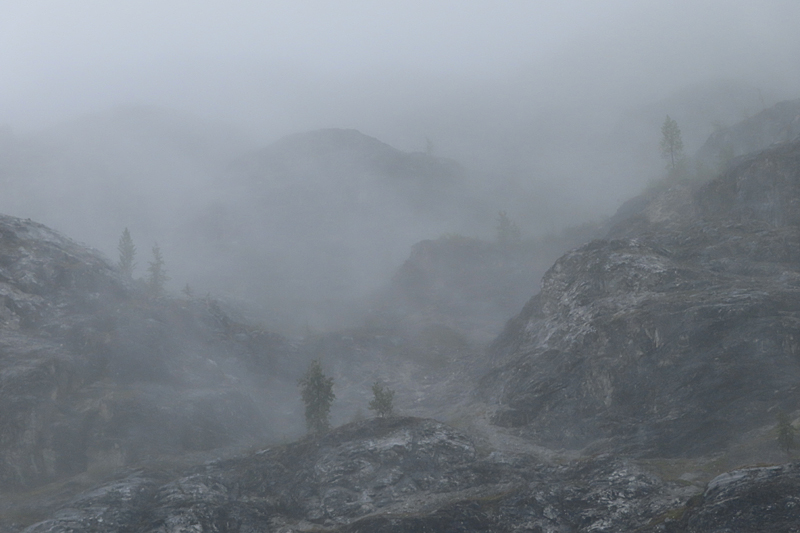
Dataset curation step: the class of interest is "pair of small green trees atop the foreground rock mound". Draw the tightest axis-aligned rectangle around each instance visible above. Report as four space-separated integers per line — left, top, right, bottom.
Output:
297 359 394 433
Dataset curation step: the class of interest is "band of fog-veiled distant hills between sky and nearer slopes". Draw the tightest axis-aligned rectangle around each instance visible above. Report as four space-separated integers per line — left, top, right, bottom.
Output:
0 77 788 332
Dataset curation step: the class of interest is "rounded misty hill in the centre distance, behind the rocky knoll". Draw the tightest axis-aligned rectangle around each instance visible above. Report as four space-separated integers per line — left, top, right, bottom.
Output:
186 129 488 331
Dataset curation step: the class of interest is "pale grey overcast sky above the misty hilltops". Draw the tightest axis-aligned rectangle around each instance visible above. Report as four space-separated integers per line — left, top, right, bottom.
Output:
6 0 800 144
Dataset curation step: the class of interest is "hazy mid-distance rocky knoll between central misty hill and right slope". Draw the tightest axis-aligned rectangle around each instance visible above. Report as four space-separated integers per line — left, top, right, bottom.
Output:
372 224 602 344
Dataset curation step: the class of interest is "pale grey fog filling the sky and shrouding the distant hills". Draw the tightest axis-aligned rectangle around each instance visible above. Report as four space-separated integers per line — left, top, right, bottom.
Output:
0 0 800 329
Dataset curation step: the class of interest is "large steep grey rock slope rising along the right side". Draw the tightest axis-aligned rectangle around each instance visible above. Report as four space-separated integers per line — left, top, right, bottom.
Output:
483 139 800 456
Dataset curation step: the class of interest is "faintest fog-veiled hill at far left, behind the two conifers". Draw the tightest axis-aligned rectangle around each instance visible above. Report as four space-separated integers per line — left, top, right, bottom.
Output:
0 106 253 257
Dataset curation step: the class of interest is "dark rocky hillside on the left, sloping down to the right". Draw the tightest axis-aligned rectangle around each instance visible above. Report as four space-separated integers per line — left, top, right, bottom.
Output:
0 216 294 491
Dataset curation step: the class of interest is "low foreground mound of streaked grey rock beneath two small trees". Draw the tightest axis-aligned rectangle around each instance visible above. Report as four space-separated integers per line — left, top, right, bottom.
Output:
20 418 687 533
